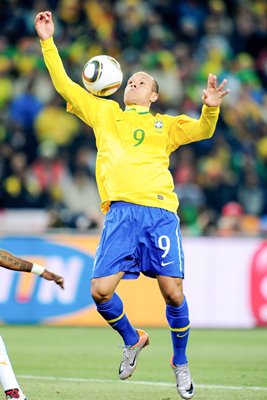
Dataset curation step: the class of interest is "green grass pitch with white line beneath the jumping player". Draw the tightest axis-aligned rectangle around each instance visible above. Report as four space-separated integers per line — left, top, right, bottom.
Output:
0 326 267 400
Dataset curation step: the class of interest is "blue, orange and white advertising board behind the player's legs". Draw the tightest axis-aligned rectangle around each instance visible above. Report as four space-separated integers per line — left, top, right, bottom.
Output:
0 234 267 328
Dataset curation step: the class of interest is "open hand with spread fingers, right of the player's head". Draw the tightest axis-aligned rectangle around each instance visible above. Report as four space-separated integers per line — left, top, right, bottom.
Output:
202 74 230 107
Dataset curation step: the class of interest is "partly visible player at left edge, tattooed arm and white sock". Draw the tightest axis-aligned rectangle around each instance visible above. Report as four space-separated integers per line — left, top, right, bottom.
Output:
0 249 64 400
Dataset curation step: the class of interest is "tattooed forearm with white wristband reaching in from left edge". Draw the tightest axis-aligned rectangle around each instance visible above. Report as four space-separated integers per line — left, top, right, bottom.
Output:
0 249 64 289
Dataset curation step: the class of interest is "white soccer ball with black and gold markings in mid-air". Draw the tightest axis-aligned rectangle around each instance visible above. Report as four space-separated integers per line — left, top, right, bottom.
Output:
82 55 123 97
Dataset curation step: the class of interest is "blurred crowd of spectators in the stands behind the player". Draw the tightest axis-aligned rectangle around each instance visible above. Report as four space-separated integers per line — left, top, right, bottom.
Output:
0 0 267 235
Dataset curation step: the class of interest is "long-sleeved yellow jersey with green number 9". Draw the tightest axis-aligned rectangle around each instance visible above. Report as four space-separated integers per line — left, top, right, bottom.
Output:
41 37 219 213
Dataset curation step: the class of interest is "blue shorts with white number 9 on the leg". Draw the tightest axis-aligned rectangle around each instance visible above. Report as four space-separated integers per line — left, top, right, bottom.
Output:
92 201 184 279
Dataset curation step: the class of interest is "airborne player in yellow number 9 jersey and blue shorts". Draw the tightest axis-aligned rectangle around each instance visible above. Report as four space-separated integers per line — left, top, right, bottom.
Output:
35 11 229 399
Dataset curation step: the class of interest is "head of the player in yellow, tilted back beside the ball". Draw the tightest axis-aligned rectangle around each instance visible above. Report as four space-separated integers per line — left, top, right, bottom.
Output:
124 71 159 107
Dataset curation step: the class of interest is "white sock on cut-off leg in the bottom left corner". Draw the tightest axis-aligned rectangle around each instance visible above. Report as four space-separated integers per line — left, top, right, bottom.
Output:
0 336 20 391
